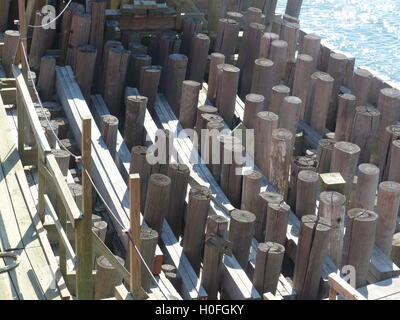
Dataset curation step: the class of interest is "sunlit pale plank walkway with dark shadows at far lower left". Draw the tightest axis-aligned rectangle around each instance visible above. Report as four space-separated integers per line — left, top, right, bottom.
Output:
0 92 65 300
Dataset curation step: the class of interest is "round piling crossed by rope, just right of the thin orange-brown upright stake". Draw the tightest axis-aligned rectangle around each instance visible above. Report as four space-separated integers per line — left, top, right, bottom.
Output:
140 226 158 292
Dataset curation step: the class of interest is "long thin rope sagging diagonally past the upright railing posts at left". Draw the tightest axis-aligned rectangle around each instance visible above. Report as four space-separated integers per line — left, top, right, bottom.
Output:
17 35 174 300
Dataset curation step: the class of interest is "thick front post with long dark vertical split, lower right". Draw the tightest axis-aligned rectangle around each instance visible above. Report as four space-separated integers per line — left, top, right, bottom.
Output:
293 215 331 300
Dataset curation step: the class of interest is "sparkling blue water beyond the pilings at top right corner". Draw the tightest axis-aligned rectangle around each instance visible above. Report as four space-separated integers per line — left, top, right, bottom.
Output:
277 0 400 88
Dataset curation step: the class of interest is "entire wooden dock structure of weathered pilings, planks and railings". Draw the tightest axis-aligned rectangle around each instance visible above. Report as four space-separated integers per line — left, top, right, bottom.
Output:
0 0 400 300
